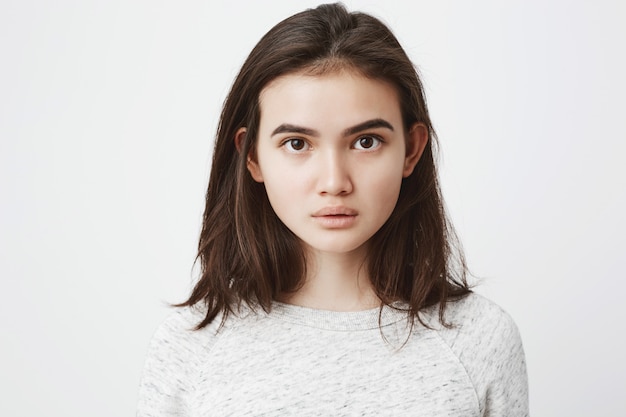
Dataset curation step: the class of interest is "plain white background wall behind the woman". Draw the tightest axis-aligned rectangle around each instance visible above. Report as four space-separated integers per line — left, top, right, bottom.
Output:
0 0 626 417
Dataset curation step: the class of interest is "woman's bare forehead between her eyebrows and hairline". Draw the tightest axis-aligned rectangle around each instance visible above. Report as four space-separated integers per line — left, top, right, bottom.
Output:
259 71 402 133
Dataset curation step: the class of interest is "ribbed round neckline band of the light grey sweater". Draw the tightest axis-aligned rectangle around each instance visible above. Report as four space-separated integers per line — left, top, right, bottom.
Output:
270 301 407 331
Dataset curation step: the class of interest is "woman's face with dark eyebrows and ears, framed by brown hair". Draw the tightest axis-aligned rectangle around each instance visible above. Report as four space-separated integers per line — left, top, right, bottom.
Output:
248 71 428 253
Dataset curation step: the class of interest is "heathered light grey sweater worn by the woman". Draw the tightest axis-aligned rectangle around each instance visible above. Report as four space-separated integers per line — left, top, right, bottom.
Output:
137 294 528 417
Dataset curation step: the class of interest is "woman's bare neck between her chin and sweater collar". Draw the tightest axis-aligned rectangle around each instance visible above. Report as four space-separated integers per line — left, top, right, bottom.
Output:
280 245 380 311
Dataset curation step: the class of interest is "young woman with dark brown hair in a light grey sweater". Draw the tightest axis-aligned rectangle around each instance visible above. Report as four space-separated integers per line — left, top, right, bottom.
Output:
138 5 528 417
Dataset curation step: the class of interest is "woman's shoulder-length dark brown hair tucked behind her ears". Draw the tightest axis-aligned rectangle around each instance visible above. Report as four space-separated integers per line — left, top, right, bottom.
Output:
179 4 469 328
